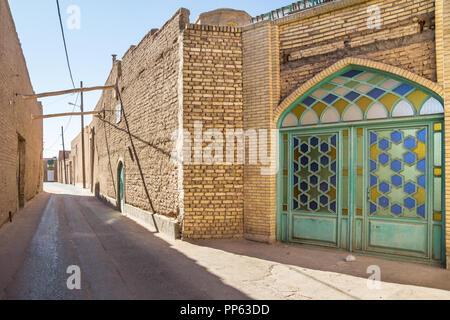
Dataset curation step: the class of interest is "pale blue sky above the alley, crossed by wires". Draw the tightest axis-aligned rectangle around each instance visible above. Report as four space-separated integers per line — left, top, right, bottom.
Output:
9 0 292 157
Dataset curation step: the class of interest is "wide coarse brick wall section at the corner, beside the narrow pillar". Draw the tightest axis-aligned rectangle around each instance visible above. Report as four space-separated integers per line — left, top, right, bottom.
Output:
183 25 244 239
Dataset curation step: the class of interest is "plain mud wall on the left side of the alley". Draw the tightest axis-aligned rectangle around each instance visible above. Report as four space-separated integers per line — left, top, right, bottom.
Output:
0 0 43 226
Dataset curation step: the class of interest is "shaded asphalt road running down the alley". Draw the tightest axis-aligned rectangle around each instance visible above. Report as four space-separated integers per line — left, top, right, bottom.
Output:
0 184 247 300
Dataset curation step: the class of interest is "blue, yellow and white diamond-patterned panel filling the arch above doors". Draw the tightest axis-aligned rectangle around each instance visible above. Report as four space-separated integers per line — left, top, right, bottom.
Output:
282 66 444 128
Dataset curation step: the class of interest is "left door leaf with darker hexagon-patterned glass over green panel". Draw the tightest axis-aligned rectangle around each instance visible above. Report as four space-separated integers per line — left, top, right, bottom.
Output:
290 132 339 246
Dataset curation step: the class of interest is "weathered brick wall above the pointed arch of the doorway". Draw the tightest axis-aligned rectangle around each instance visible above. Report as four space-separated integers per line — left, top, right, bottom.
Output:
278 0 437 98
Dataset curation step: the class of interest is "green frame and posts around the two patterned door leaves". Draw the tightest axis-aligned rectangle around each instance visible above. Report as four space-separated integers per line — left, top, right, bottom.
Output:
276 114 447 265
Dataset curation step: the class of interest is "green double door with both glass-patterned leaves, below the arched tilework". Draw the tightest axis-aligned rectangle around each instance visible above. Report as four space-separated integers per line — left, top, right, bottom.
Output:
279 120 443 262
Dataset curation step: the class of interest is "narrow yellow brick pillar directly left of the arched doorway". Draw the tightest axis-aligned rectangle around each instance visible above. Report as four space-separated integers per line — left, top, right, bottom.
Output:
243 21 280 242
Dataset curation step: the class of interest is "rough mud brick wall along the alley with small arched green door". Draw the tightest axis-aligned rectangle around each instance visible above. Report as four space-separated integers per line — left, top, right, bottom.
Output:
86 9 189 218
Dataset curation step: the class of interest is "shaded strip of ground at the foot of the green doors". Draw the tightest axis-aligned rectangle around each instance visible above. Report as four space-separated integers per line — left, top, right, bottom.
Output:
184 239 450 290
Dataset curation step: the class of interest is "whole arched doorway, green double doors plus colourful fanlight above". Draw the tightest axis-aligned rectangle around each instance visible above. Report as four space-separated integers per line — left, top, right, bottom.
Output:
277 65 445 263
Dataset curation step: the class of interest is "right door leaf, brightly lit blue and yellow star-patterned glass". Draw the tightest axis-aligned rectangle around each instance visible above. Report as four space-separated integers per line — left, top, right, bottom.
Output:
366 126 429 257
